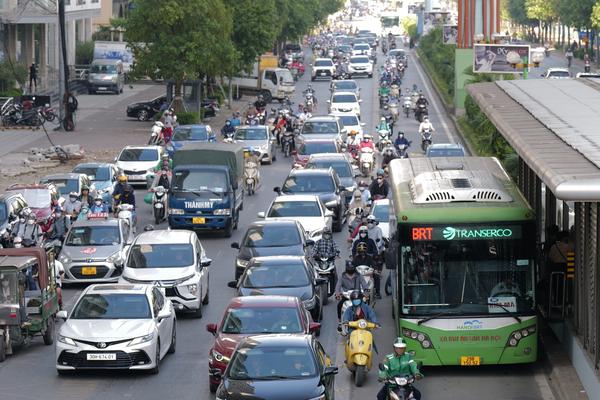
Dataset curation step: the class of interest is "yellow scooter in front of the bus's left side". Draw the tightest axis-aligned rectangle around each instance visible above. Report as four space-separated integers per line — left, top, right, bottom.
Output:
342 319 379 387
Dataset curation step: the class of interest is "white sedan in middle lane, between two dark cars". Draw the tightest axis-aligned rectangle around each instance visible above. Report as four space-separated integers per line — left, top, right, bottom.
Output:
258 194 333 242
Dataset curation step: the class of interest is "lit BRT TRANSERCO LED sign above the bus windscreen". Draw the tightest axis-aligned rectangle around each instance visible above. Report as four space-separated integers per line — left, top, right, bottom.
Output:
411 225 521 241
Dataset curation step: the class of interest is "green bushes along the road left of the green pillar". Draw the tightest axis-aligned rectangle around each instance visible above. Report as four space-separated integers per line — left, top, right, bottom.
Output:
419 27 456 98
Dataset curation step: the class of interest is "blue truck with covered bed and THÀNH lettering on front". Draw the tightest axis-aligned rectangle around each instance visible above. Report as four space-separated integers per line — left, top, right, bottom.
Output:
168 143 244 237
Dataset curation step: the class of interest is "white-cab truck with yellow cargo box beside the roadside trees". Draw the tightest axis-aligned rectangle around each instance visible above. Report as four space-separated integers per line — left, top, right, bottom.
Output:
231 54 296 103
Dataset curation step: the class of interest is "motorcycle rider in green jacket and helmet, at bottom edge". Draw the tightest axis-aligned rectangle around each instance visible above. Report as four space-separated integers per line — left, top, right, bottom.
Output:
377 337 423 400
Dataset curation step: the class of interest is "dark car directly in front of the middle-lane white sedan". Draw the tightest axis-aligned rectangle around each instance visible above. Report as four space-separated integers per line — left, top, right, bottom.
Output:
231 220 314 281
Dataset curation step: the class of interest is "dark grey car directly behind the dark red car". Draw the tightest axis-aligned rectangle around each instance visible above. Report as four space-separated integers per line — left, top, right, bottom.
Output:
227 256 327 321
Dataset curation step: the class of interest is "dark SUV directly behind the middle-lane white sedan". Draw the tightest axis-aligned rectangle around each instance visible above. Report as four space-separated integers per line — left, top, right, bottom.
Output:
274 168 346 232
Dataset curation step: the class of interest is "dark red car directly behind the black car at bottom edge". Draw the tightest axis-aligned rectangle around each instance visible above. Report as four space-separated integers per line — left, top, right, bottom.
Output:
206 296 321 393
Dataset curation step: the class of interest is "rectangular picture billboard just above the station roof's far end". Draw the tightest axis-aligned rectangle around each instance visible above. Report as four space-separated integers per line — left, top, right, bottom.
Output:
473 44 530 74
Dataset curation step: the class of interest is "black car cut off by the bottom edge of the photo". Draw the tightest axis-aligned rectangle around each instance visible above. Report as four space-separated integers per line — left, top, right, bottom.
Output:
216 335 338 400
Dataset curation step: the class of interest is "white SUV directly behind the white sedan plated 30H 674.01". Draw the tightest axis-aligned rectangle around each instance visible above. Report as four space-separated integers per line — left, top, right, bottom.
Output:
119 230 212 318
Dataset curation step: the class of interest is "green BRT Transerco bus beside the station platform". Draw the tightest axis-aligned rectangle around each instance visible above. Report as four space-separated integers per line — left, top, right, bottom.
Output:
389 157 537 366
